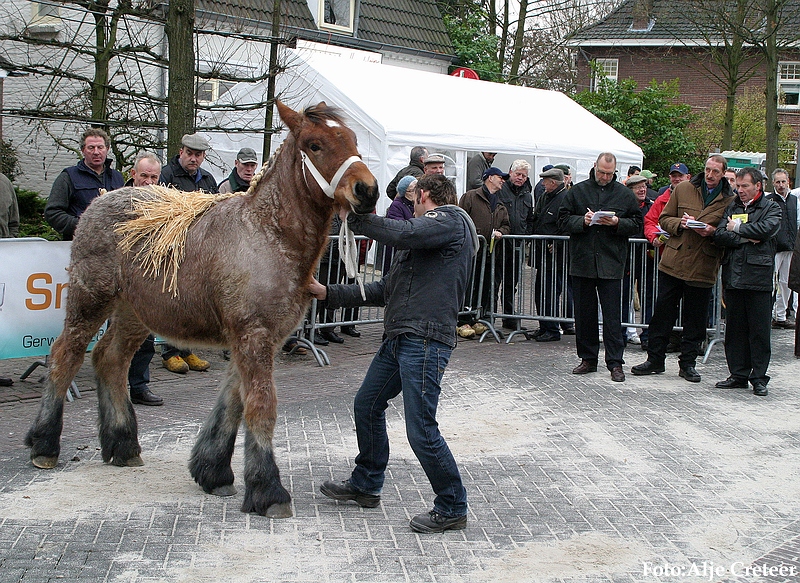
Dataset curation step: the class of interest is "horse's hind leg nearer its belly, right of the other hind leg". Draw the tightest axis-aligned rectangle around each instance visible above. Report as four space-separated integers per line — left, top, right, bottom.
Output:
92 304 149 466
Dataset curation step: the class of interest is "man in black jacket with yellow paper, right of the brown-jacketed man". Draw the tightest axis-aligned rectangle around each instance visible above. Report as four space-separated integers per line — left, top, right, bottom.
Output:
714 168 781 397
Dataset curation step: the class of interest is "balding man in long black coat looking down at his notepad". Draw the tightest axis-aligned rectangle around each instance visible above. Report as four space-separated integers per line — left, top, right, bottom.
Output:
558 152 643 382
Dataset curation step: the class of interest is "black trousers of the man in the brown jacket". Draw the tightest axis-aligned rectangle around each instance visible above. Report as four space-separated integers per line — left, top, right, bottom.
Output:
647 271 712 368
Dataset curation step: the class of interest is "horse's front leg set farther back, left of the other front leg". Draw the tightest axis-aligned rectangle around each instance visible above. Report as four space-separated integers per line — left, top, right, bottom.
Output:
189 362 242 496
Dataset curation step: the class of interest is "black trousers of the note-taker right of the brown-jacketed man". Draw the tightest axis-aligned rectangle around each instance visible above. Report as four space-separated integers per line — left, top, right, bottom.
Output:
725 289 772 385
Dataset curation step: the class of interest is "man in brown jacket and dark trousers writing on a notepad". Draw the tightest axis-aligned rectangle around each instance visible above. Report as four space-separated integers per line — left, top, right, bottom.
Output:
631 154 734 383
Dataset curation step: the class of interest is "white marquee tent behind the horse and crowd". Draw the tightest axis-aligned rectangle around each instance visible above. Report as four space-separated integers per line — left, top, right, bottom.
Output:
209 50 642 212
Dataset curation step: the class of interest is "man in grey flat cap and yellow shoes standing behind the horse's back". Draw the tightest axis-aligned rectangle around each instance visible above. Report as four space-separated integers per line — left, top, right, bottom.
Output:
159 134 217 374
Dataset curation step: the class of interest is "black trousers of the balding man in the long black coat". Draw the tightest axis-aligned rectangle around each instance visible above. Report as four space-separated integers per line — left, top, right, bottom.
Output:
572 275 625 370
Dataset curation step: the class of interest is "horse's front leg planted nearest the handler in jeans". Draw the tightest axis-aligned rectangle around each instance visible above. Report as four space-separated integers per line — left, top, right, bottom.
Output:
240 351 292 518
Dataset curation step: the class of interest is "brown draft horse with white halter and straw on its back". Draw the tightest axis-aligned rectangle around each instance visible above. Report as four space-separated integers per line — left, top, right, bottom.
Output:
25 102 378 518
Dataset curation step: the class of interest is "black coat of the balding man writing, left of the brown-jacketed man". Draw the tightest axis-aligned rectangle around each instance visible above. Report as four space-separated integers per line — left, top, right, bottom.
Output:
558 168 643 279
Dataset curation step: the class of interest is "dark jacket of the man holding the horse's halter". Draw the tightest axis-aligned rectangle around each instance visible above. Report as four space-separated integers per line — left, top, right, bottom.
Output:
327 205 478 347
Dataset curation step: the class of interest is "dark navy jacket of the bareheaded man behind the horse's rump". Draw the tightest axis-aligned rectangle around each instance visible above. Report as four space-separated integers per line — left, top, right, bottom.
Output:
44 160 125 241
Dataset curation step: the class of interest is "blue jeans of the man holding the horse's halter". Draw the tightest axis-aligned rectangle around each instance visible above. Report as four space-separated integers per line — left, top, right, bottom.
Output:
350 334 467 517
